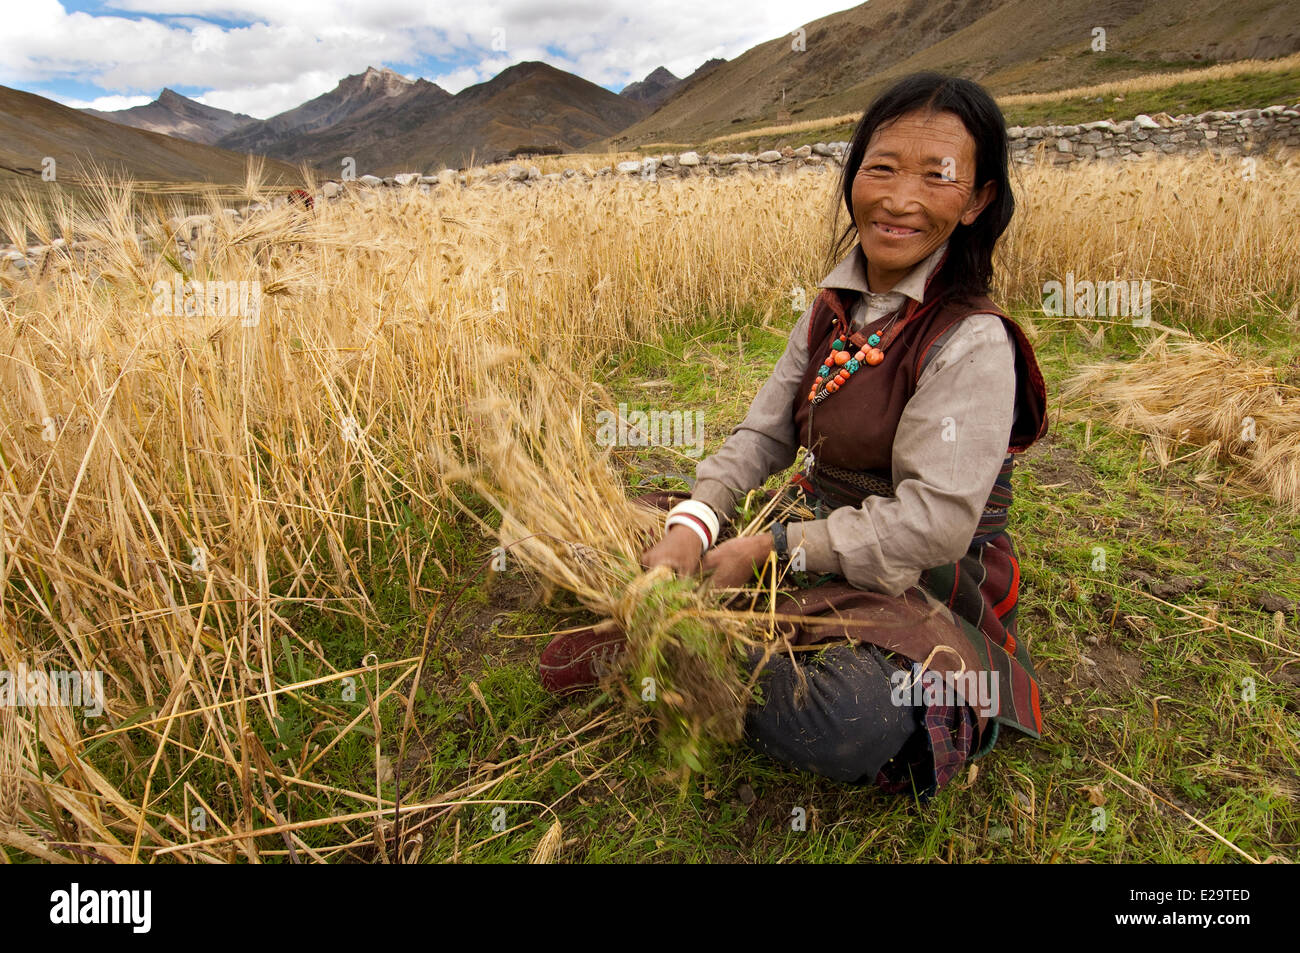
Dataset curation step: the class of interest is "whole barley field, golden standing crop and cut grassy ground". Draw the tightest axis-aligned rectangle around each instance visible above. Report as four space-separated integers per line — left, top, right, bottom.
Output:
0 148 1300 863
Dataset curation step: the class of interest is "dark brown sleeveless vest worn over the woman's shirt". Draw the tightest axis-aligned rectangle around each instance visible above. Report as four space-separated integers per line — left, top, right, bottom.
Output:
792 280 1048 480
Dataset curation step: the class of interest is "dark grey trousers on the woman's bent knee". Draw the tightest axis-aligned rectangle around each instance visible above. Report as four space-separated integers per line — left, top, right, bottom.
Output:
745 642 923 784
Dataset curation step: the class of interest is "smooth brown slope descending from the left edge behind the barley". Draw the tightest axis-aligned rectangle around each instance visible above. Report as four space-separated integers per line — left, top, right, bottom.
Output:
0 86 300 186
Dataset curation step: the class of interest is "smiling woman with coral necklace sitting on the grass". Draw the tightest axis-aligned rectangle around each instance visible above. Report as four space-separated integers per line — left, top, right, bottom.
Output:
542 73 1047 794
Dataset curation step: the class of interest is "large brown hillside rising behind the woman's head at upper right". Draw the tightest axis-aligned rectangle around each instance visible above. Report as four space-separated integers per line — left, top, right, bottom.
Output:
595 0 1300 148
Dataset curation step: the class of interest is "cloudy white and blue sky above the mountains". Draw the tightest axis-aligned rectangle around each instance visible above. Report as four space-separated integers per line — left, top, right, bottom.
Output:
0 0 855 118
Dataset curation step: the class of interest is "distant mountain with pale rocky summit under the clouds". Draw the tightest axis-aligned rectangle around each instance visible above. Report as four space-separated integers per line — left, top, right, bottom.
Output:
218 66 451 160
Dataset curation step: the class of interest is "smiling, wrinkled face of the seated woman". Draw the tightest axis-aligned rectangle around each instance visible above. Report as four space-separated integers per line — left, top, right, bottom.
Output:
853 112 997 294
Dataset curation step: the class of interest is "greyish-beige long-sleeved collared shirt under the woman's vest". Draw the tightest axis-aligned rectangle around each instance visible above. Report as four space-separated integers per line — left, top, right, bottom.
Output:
692 237 1015 595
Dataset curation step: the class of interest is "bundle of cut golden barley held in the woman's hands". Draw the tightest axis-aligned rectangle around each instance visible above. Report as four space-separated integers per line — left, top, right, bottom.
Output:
447 358 771 771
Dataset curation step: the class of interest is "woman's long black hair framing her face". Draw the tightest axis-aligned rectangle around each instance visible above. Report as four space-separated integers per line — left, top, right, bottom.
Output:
827 73 1015 298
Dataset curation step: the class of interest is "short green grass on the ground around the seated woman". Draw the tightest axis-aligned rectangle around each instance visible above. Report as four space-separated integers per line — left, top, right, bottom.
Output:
226 297 1300 863
